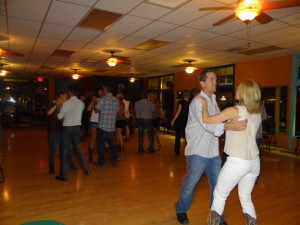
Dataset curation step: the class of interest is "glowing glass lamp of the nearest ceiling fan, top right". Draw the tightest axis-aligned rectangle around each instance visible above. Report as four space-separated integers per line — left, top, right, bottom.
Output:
235 0 262 21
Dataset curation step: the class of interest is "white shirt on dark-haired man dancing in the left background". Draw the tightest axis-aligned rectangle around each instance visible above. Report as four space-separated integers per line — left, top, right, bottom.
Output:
57 96 84 127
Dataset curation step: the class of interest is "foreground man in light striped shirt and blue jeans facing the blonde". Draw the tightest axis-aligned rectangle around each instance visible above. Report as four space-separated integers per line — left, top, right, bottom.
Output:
175 69 247 225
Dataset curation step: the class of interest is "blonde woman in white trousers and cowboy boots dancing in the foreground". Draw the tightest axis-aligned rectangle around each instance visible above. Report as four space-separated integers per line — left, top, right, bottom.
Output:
200 80 261 225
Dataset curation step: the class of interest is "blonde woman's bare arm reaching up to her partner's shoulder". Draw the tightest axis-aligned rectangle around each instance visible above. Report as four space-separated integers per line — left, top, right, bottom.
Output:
201 97 239 123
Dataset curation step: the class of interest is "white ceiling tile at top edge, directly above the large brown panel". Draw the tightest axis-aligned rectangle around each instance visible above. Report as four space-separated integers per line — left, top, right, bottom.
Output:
95 0 144 13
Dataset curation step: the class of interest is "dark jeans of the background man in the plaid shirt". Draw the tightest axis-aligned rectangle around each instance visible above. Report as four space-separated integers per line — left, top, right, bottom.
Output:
97 128 119 165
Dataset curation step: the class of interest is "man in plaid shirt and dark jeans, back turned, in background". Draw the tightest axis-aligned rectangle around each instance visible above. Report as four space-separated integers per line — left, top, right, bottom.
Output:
95 85 121 166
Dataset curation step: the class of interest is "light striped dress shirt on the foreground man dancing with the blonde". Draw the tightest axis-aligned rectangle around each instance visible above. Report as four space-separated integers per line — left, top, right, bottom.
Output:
185 91 224 158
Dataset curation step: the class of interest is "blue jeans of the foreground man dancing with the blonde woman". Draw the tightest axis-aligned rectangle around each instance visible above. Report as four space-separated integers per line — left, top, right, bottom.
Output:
175 155 222 221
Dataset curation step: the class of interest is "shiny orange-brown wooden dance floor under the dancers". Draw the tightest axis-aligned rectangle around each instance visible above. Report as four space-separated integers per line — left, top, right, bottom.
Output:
0 127 300 225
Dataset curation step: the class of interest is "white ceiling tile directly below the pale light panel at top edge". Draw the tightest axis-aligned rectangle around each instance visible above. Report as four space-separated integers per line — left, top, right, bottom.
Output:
129 3 172 20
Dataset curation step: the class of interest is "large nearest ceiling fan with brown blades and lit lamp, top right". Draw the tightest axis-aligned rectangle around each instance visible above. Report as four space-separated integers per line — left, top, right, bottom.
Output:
199 0 300 26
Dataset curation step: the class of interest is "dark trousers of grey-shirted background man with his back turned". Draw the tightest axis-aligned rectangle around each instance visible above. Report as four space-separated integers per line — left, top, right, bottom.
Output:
138 119 154 152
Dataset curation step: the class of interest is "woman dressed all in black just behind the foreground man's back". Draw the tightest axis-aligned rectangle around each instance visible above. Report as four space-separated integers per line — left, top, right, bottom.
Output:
171 91 190 155
